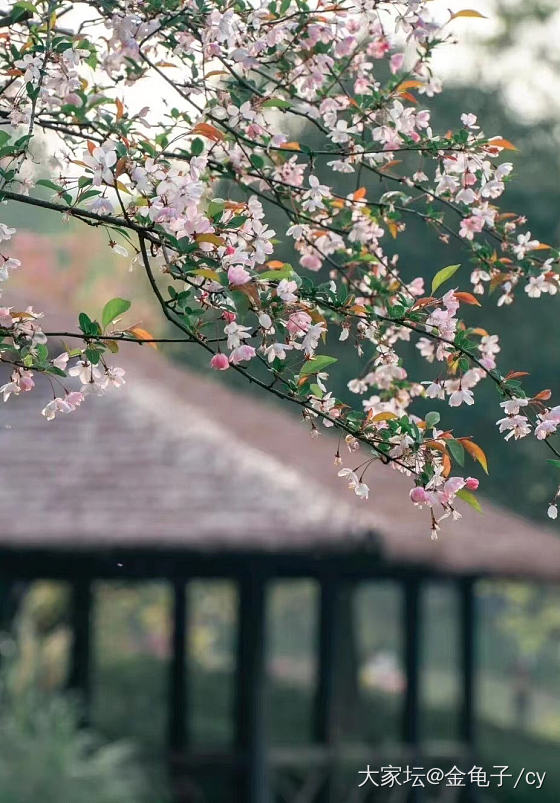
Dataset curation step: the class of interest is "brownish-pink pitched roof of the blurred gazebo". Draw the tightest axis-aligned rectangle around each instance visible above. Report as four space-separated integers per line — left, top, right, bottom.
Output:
0 346 560 580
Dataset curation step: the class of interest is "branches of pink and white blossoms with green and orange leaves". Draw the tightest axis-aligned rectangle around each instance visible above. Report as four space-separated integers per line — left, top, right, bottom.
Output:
0 0 560 536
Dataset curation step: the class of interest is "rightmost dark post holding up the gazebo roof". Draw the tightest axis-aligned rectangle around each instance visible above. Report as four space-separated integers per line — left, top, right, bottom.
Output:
458 579 476 748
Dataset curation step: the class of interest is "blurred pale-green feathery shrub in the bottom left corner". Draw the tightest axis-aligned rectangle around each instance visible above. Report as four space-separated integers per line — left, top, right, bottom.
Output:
0 642 151 803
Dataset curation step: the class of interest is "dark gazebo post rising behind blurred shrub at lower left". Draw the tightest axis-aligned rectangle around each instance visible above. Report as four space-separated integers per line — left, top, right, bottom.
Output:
68 580 92 725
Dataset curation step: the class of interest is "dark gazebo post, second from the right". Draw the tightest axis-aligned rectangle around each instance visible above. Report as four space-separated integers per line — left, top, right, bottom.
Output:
402 578 421 746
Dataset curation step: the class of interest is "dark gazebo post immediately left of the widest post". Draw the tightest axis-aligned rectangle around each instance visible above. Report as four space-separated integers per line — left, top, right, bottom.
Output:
168 580 187 761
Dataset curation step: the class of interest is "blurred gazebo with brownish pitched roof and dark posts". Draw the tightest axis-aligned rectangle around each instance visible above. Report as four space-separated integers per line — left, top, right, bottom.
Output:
0 346 560 803
